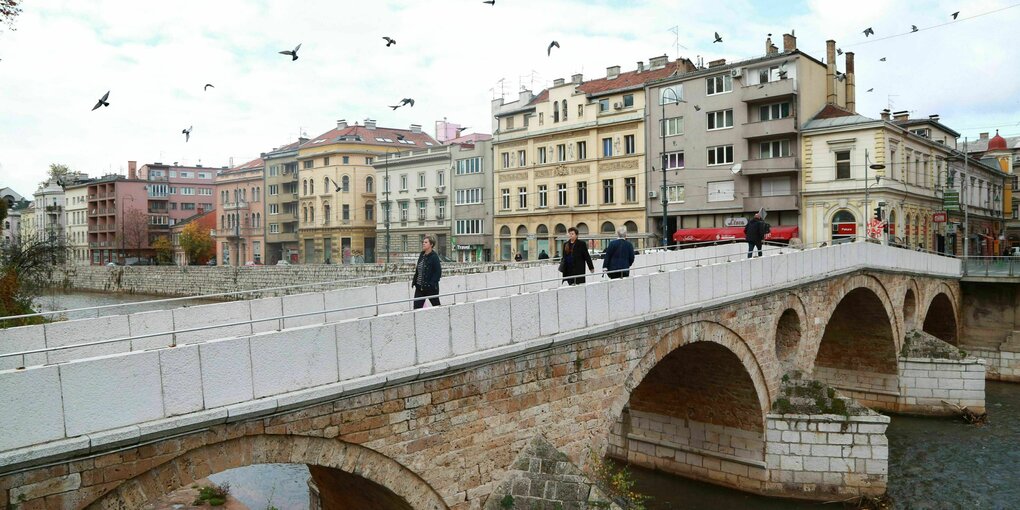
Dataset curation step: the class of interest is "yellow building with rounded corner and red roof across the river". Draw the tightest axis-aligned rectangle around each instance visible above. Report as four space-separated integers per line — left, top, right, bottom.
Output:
298 120 441 264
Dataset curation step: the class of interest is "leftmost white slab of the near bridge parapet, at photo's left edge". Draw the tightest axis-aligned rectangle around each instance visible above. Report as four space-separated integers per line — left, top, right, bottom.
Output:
0 366 64 450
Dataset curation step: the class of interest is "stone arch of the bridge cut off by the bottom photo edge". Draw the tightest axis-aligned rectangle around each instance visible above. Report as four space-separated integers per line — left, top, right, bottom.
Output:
86 435 448 510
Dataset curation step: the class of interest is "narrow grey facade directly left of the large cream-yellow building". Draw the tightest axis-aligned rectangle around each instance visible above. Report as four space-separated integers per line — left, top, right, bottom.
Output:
450 138 493 262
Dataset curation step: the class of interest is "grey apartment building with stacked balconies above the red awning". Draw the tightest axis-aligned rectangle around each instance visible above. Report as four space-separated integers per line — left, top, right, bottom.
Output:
643 34 832 244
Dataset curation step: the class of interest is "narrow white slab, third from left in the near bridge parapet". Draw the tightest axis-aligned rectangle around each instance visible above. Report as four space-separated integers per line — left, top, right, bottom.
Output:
159 346 203 416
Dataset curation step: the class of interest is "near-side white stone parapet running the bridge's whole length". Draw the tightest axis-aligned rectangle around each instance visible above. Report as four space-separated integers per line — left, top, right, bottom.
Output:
0 243 959 466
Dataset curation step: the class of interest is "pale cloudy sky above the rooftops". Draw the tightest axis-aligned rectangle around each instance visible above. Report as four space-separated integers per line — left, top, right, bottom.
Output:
0 0 1020 195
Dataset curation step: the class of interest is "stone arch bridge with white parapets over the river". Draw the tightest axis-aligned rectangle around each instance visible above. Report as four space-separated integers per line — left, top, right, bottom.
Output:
0 243 984 509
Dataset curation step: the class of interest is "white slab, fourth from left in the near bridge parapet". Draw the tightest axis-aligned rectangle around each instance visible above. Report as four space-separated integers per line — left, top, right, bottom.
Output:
199 337 254 409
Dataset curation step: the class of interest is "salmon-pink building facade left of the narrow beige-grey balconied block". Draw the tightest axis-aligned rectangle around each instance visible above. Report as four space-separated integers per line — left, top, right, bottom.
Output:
213 158 265 266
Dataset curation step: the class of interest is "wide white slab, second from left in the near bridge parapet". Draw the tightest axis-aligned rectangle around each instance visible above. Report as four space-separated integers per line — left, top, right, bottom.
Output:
60 351 163 437
